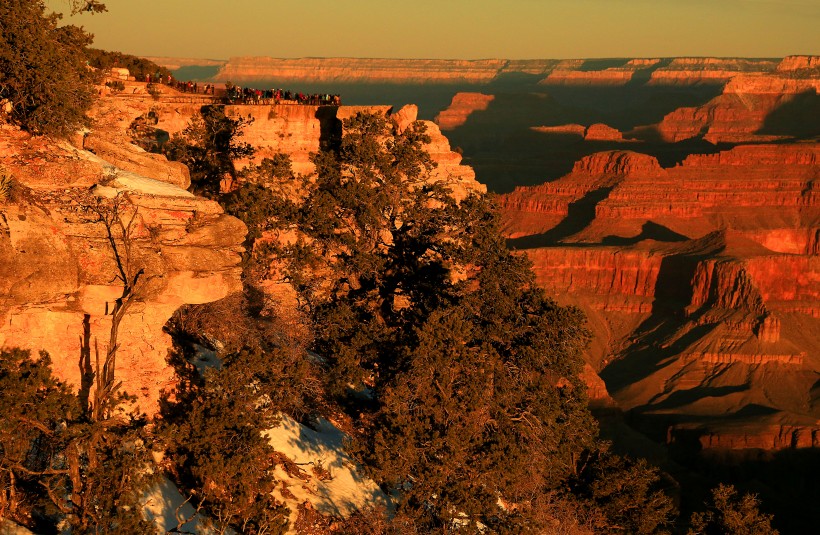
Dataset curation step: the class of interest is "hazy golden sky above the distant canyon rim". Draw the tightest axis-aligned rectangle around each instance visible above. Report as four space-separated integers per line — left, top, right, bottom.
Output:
51 0 820 59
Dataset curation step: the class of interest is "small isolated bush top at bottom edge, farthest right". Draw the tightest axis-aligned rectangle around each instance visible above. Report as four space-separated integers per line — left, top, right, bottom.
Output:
689 484 778 535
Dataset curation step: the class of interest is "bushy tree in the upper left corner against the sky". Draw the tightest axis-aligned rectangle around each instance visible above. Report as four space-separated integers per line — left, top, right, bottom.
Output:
0 0 96 136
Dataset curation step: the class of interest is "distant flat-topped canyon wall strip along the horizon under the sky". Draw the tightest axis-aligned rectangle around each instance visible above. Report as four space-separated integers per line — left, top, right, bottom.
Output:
148 56 796 86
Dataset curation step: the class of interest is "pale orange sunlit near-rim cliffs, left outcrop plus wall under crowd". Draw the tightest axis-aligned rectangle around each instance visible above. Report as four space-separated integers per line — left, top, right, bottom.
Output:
0 81 486 416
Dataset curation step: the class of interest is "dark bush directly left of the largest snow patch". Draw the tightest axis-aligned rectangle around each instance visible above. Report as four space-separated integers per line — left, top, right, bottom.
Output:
159 350 289 534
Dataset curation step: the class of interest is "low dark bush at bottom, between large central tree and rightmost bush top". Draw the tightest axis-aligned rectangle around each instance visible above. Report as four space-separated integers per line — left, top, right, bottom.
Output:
569 447 674 534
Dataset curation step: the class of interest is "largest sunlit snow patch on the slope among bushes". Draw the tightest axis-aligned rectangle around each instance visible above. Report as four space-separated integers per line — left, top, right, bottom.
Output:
265 416 390 525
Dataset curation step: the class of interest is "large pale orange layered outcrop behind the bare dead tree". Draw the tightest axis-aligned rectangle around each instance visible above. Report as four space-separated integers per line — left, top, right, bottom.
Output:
0 124 246 414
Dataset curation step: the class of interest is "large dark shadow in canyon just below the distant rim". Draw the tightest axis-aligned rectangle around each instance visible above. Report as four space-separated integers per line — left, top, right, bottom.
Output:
444 82 720 193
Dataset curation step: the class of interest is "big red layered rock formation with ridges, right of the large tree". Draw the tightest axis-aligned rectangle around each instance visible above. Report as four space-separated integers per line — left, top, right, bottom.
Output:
502 143 820 449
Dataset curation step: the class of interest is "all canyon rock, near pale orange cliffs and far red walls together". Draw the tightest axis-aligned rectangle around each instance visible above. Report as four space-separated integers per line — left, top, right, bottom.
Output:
0 52 820 528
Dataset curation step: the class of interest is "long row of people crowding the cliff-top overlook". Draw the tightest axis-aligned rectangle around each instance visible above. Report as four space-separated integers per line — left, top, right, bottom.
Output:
145 73 342 106
